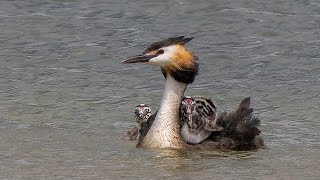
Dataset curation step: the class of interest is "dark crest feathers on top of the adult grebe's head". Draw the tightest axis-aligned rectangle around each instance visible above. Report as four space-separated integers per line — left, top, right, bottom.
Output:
143 36 193 54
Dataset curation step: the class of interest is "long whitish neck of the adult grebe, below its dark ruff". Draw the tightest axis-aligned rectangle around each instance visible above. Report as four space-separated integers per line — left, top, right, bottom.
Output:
140 74 187 149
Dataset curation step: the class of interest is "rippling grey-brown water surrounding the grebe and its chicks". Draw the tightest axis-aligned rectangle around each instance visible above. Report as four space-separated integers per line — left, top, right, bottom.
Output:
0 0 320 179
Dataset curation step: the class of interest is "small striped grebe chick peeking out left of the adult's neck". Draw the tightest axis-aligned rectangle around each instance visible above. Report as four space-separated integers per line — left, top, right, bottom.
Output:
122 104 151 141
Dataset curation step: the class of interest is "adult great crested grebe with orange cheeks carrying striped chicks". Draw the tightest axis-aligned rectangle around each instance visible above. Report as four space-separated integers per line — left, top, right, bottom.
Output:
121 36 264 150
